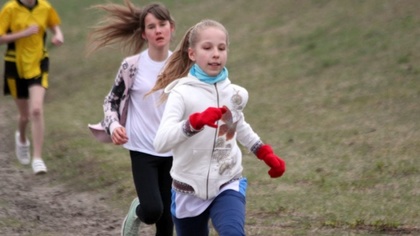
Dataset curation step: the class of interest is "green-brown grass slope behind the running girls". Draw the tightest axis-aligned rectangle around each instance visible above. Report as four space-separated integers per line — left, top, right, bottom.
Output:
1 0 420 235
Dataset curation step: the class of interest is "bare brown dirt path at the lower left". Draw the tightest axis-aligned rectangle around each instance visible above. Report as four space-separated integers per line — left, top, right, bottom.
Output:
0 98 151 236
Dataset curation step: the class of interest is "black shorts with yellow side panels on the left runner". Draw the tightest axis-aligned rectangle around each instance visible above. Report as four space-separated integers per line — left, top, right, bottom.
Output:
4 57 49 99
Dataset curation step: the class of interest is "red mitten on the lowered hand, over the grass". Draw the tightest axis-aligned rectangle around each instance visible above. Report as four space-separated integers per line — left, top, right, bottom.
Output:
256 144 286 178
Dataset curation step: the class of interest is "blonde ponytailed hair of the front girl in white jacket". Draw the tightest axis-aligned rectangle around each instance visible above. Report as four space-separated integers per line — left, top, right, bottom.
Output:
148 19 229 101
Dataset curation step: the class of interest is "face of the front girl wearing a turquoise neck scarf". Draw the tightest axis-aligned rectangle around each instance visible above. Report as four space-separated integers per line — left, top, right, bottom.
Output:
188 27 227 76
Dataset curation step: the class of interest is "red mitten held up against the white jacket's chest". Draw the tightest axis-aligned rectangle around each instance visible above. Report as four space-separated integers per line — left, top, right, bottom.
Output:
189 107 227 130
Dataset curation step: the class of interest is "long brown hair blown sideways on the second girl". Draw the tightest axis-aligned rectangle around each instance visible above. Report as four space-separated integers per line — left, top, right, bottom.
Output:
87 0 175 55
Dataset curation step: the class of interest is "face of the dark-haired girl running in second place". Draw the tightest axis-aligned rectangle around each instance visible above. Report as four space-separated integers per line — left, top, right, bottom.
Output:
142 13 174 49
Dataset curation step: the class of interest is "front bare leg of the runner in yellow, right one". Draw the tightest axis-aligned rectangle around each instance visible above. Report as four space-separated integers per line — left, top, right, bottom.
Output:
29 85 45 160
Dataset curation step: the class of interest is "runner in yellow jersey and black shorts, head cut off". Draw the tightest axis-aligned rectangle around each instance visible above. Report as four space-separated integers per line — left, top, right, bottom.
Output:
0 0 64 174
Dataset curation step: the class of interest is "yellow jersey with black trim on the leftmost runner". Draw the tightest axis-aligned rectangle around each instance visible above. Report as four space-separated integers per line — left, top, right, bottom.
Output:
0 0 61 79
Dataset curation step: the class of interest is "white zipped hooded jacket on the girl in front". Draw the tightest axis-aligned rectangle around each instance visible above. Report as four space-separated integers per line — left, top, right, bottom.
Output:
154 75 261 200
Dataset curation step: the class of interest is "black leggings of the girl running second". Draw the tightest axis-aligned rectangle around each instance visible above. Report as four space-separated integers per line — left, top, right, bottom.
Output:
130 151 174 236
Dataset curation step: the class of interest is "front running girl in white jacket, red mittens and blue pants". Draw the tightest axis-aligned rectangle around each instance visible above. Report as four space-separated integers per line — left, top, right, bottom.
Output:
152 20 286 236
